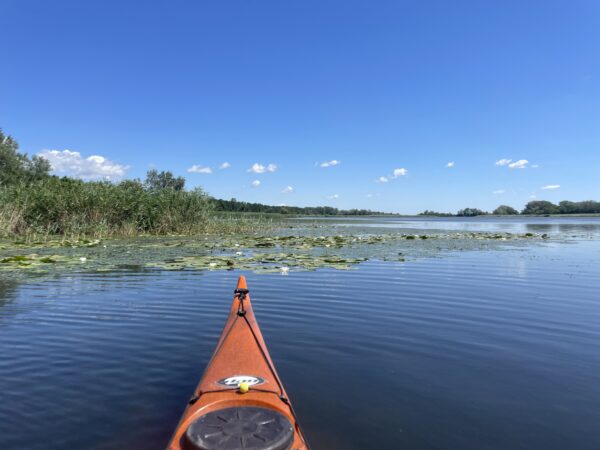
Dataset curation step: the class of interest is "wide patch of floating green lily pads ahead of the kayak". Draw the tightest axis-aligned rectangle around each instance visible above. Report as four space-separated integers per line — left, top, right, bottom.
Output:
0 227 547 276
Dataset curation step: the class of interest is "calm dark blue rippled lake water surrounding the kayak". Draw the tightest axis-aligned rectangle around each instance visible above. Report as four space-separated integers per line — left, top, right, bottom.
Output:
0 218 600 450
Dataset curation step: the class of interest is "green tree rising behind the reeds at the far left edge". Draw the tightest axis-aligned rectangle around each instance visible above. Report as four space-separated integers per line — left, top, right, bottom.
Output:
0 130 50 186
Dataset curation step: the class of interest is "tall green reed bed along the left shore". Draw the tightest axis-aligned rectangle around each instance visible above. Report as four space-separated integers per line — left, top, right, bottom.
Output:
0 178 272 241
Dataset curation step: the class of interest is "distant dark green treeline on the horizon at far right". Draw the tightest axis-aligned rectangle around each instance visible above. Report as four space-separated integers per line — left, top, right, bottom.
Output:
419 200 600 217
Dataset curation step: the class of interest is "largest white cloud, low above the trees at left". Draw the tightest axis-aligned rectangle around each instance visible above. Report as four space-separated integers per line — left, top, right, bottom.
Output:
38 150 129 181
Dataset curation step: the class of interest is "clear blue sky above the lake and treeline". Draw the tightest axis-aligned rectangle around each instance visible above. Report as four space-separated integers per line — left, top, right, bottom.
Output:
0 0 600 213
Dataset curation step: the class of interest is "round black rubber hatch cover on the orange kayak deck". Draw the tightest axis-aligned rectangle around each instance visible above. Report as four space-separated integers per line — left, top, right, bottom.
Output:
181 407 294 450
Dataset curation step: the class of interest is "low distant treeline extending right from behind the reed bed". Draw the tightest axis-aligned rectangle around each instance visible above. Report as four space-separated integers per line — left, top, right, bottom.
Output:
213 198 385 216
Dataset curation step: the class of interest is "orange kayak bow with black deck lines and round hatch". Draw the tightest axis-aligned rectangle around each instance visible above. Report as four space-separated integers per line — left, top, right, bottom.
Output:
168 276 308 450
